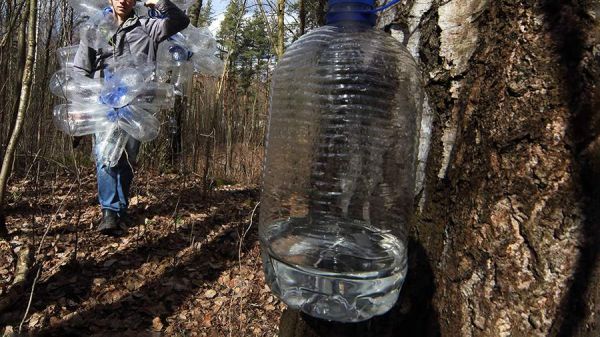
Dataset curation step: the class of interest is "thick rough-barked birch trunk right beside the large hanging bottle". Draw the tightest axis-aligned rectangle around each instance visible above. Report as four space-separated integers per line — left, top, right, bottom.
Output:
280 0 600 337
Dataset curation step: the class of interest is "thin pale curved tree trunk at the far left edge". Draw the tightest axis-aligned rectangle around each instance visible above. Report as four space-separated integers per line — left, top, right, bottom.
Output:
0 0 37 234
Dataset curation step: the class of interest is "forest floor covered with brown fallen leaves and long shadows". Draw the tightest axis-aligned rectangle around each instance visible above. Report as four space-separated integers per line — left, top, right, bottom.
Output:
0 169 285 337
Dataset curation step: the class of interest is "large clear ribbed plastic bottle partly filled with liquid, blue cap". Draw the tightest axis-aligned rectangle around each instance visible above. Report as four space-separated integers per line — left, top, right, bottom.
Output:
259 0 424 322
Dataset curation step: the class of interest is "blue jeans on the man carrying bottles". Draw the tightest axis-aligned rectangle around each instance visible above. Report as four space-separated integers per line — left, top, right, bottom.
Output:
94 137 140 213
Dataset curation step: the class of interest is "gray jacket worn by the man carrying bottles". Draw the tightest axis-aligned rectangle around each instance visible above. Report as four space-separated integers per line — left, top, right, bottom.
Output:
74 0 190 78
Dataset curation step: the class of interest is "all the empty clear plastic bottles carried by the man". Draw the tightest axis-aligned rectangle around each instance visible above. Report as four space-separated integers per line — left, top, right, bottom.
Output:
50 0 223 166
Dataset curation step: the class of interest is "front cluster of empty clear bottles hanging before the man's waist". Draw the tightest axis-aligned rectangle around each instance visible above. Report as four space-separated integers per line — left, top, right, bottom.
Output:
50 51 173 166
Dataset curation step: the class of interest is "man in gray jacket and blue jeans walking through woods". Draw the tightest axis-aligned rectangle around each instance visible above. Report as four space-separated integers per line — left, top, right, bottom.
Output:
74 0 190 236
